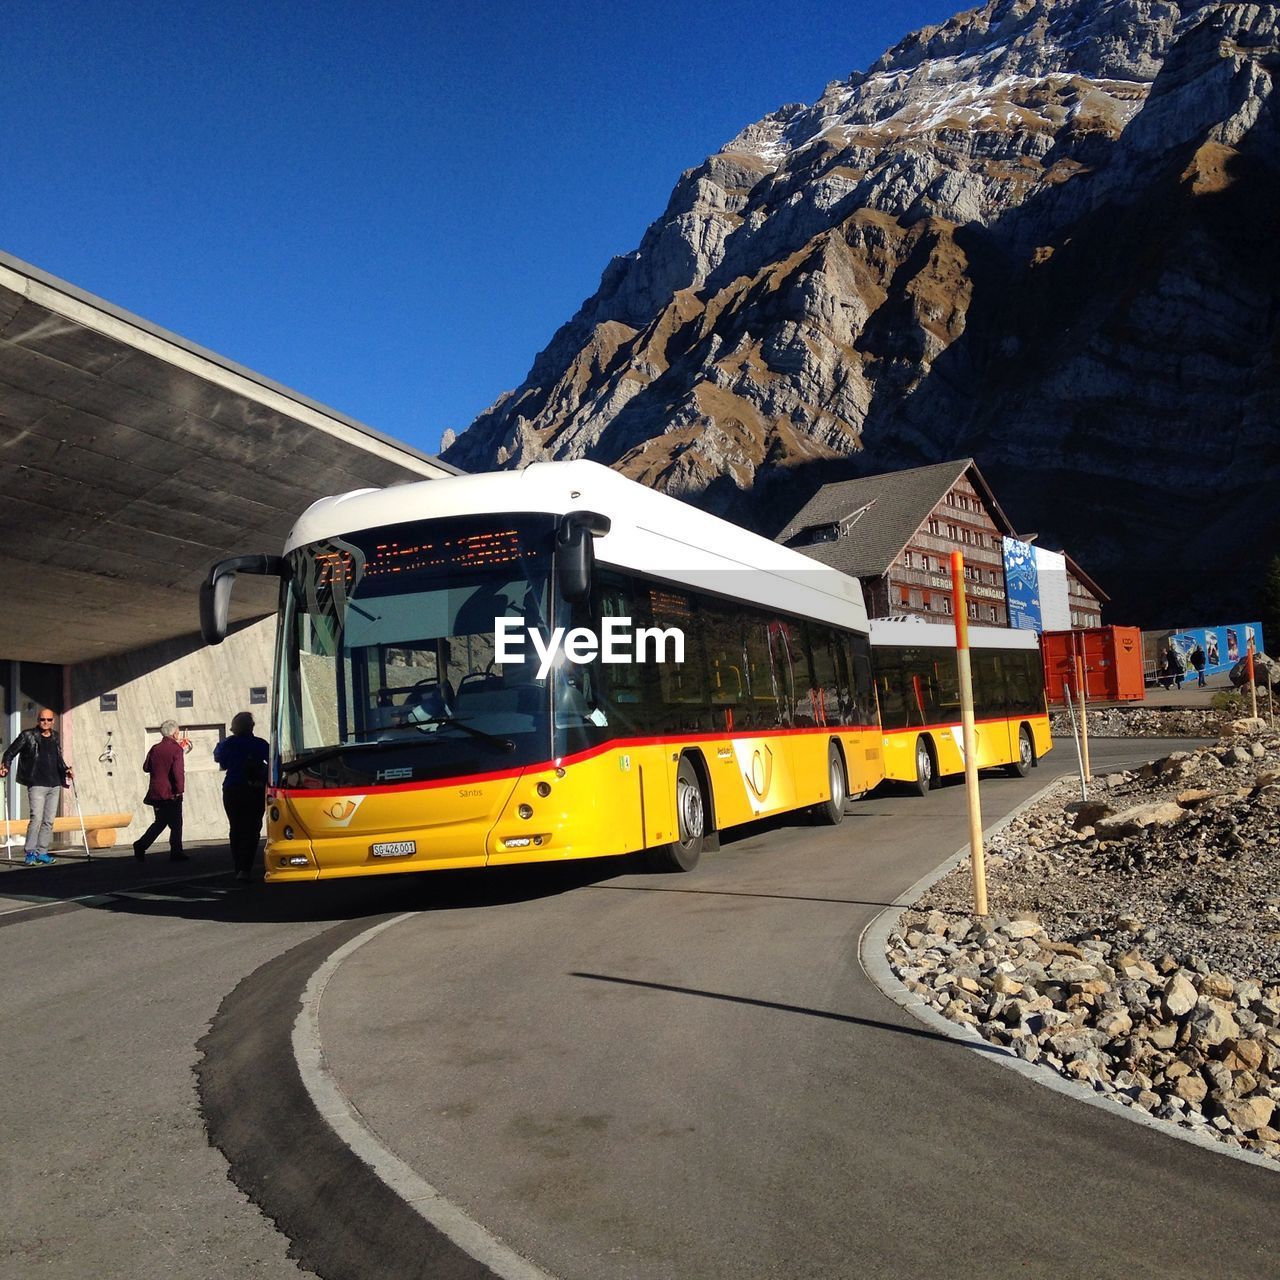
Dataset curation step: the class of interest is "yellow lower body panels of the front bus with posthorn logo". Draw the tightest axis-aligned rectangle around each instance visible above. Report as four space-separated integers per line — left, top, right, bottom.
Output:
266 727 885 882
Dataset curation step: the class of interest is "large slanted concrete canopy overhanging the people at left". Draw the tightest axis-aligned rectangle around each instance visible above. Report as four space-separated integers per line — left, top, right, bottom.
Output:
0 253 456 663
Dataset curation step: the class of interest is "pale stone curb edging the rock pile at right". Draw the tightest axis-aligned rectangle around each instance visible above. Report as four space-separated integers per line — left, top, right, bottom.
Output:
858 777 1280 1174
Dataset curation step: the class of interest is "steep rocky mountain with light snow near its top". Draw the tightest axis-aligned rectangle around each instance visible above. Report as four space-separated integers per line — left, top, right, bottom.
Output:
444 0 1280 629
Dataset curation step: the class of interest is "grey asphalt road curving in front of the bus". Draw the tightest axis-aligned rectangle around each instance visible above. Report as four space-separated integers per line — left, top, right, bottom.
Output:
0 741 1280 1280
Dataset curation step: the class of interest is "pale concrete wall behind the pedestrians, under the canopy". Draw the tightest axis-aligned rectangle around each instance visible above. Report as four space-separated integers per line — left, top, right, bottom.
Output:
61 617 275 849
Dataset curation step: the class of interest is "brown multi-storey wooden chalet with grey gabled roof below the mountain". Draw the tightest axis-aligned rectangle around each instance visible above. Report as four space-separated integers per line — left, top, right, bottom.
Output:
777 458 1106 627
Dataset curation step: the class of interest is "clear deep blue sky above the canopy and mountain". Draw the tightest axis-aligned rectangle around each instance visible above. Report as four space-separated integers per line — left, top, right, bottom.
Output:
0 0 966 452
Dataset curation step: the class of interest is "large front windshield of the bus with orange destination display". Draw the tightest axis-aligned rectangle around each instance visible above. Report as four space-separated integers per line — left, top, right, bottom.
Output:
276 515 554 787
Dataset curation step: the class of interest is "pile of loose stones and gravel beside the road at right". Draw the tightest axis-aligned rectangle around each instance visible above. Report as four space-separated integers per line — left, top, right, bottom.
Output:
887 722 1280 1160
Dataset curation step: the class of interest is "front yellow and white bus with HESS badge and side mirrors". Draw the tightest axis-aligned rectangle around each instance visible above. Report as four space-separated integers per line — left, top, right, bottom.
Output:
201 462 882 882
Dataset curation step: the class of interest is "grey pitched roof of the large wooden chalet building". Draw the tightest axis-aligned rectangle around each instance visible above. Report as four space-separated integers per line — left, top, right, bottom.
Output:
777 458 1016 577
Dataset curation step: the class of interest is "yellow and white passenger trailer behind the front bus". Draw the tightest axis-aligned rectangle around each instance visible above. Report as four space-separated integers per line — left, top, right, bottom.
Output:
870 621 1053 795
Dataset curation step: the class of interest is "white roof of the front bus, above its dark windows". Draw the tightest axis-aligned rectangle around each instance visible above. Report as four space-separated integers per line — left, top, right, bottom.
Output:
284 460 867 632
